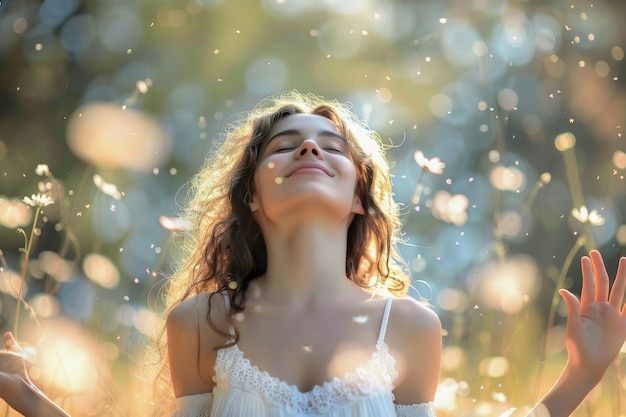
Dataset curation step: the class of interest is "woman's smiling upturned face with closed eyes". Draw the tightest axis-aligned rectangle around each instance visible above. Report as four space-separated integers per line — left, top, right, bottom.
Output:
250 113 363 221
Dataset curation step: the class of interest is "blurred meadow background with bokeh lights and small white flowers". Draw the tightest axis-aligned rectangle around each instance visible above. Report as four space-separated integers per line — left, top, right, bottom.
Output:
0 0 626 417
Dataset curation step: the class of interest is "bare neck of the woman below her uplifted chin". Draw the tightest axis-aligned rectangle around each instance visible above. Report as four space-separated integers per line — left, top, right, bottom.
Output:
261 222 357 307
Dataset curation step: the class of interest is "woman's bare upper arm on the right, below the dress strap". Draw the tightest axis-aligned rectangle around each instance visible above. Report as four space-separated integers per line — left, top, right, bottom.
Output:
389 298 442 404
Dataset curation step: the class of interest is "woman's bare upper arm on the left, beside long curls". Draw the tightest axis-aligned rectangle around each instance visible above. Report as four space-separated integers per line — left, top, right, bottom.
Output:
166 294 224 397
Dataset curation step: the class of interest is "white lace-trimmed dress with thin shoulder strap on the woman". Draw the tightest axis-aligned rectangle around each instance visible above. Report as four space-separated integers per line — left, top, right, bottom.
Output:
172 298 436 417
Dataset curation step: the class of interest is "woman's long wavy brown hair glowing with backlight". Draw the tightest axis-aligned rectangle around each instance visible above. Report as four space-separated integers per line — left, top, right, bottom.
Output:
149 92 409 412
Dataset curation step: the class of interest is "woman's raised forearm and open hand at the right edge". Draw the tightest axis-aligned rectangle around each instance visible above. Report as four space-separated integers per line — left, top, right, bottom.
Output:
527 251 626 417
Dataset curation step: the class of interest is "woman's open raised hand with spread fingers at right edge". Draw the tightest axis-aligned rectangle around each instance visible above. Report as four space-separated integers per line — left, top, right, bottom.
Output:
560 250 626 382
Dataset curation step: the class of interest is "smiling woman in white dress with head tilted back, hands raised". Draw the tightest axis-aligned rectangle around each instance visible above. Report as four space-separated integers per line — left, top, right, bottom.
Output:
0 94 626 417
